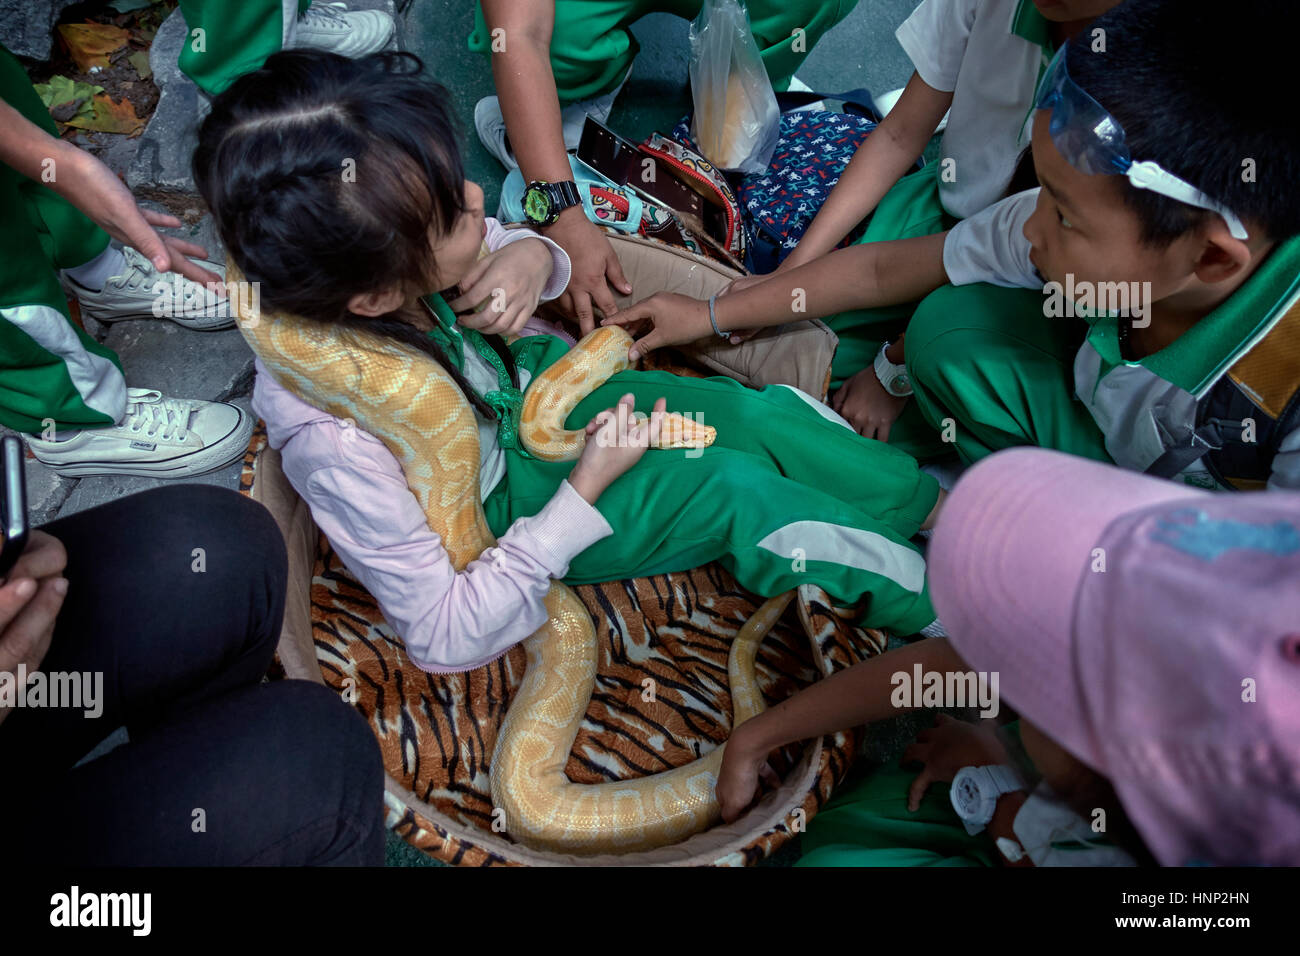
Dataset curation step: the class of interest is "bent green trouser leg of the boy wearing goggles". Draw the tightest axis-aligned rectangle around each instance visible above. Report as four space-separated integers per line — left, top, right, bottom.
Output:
906 285 1110 463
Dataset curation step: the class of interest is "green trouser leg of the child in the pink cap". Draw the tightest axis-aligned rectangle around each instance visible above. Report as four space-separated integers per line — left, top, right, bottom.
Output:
794 766 997 866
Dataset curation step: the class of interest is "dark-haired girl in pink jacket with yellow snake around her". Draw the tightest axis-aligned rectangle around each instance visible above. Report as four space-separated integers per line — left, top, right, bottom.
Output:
195 52 940 671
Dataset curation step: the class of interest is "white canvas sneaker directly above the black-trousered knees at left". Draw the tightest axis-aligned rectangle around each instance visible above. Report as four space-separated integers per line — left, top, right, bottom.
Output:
26 389 254 477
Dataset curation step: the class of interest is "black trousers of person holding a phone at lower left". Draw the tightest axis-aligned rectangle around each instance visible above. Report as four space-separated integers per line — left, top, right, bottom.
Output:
0 485 384 866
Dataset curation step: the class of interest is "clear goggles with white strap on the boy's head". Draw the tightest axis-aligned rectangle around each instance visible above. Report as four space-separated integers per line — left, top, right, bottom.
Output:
1036 44 1249 241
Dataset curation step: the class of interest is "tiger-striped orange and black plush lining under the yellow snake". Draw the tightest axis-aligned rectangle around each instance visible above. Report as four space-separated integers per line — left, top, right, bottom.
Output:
242 424 884 866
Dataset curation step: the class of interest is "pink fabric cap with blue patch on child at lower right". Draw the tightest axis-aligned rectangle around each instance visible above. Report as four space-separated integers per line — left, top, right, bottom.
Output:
928 449 1300 865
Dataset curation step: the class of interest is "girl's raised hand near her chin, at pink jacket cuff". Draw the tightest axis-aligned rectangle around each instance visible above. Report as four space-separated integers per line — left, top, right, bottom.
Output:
447 238 554 336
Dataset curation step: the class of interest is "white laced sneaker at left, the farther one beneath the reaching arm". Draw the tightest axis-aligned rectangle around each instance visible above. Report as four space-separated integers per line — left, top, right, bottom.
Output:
62 246 235 332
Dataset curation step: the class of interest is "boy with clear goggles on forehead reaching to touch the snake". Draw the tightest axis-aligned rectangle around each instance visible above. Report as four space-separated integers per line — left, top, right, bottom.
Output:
616 0 1300 489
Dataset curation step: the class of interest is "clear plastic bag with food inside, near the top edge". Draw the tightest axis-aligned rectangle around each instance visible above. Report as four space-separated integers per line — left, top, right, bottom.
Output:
690 0 781 174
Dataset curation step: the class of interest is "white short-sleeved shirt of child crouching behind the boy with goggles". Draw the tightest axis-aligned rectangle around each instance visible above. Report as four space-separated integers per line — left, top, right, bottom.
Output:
896 0 1052 219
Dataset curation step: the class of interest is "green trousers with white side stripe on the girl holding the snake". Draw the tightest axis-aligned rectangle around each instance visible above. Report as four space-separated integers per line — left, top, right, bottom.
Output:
485 337 939 633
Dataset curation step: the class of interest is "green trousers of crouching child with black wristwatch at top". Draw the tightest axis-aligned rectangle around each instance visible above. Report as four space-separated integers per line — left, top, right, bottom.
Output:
469 0 858 104
